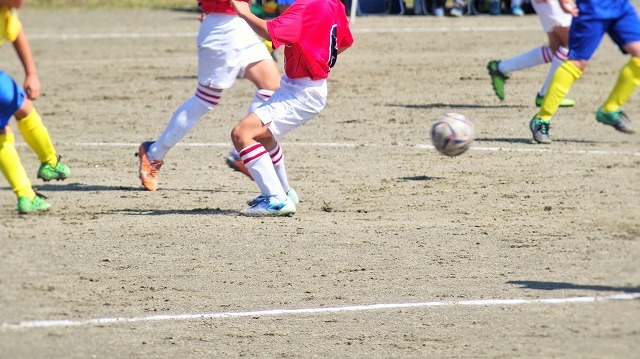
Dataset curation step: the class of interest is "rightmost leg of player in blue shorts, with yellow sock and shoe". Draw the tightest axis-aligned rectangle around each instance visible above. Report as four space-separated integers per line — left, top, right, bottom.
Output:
596 8 640 133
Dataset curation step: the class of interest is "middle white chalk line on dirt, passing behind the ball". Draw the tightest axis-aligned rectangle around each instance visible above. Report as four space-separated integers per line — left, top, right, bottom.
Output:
70 142 640 157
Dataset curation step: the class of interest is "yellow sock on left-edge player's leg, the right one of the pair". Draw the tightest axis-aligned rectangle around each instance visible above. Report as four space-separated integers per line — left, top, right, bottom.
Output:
18 108 58 167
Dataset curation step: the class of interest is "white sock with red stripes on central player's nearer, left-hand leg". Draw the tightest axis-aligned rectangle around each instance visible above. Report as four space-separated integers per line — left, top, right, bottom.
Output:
239 143 287 202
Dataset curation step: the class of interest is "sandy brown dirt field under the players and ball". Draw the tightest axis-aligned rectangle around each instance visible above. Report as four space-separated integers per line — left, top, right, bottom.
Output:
0 9 640 358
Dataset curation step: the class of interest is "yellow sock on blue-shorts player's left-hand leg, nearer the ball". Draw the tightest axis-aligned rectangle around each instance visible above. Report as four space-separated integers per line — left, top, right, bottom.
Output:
536 61 582 121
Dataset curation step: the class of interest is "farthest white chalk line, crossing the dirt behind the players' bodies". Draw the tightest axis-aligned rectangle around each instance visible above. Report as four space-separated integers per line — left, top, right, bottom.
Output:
29 26 540 40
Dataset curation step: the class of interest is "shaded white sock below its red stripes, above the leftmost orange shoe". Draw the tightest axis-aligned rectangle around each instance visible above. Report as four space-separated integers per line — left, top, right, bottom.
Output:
149 96 213 161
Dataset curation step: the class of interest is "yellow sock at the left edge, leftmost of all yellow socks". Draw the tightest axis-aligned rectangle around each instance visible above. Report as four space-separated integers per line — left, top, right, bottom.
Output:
0 133 36 199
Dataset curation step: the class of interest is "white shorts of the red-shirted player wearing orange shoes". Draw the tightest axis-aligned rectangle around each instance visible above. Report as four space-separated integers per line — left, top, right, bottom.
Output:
198 13 272 90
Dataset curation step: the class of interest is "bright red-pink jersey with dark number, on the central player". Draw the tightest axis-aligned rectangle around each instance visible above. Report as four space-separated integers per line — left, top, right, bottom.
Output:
267 0 353 80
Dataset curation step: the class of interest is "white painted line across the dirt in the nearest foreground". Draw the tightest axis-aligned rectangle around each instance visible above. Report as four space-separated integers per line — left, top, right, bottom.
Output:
0 293 640 330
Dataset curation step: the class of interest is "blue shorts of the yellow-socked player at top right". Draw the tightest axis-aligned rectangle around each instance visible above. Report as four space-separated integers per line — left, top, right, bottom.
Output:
569 2 640 60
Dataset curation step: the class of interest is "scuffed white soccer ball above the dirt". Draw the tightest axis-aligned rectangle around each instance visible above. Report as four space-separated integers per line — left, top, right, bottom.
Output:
431 113 476 156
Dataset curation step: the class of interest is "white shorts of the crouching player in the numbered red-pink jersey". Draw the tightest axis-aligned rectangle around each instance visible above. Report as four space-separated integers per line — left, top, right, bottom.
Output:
254 75 327 138
